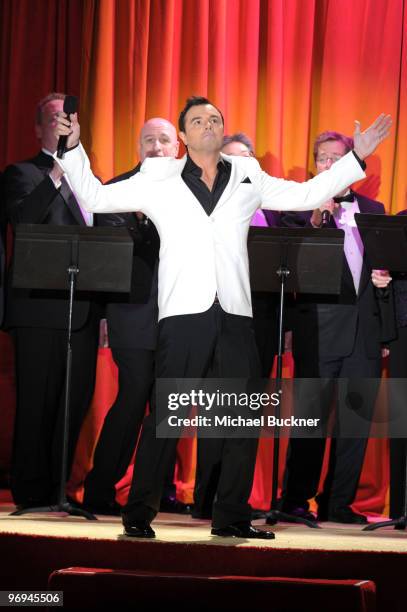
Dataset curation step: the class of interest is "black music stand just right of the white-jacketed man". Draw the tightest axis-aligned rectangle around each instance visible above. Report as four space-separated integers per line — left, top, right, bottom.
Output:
248 227 344 529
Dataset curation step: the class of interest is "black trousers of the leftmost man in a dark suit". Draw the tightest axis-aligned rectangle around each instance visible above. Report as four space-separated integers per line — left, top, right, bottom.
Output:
11 312 99 505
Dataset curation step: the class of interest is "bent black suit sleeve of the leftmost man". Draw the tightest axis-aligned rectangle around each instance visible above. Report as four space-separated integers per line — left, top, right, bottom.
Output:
4 164 59 227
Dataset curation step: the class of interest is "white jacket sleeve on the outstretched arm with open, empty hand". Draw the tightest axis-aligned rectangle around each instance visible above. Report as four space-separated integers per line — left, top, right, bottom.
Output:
249 152 366 211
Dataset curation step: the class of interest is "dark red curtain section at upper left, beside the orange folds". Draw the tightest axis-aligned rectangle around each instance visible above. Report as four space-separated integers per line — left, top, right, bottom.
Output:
0 0 83 169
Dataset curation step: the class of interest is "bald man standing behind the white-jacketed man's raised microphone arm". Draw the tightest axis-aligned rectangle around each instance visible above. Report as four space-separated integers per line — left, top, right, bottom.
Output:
83 117 183 514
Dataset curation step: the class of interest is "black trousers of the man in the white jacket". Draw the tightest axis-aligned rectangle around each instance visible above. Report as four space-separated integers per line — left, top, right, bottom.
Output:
124 304 261 528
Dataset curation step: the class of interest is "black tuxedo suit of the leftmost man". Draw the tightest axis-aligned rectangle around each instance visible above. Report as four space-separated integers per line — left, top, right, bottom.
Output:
4 152 99 504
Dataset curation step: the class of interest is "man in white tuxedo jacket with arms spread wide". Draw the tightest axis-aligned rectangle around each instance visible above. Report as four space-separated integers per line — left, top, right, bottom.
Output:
57 97 391 539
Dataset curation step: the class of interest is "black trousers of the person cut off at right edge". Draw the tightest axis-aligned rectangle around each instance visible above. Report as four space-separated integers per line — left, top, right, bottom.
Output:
389 327 407 518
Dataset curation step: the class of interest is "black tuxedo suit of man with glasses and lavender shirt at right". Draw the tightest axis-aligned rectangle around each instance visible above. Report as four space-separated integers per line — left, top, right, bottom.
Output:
282 194 389 515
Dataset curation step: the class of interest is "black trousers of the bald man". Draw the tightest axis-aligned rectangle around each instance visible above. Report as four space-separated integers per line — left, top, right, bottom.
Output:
83 347 155 506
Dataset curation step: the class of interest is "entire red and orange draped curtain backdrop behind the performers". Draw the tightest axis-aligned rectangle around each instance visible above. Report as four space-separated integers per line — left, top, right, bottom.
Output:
0 0 407 510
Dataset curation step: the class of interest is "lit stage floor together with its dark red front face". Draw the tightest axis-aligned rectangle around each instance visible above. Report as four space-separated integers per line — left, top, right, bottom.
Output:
0 501 407 612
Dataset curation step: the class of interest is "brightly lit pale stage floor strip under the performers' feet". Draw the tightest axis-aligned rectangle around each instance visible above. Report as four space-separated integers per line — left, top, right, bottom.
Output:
0 503 407 553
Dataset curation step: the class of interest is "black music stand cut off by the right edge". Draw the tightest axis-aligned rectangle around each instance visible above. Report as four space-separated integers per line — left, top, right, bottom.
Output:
355 213 407 531
